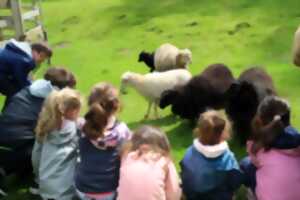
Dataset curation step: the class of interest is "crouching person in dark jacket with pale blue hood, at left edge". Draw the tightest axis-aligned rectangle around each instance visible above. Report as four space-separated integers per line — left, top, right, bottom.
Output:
0 67 76 178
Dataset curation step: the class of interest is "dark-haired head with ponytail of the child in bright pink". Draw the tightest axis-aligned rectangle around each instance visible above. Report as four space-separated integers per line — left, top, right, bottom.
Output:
252 96 290 153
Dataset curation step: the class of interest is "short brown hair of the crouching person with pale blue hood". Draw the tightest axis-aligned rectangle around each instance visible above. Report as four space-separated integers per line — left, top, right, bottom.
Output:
44 67 76 89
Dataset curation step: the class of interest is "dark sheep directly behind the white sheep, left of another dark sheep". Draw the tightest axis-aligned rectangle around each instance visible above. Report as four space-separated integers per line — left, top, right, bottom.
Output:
160 64 234 120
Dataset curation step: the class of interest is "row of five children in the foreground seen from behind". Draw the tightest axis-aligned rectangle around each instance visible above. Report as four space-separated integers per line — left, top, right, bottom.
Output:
32 72 300 200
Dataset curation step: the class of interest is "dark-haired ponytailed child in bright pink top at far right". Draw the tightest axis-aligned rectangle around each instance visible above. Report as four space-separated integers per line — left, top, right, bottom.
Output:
247 96 300 200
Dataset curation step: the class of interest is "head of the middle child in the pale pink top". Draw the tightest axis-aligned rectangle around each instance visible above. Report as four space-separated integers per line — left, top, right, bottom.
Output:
124 125 171 156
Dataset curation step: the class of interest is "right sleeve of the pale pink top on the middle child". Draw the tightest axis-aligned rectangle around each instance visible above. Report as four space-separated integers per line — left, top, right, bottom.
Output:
165 161 181 200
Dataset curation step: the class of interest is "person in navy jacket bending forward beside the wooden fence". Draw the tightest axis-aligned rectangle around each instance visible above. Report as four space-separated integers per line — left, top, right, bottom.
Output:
0 39 52 108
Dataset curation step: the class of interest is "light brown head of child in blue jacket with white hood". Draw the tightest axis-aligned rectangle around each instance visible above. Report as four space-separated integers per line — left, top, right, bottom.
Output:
195 110 230 145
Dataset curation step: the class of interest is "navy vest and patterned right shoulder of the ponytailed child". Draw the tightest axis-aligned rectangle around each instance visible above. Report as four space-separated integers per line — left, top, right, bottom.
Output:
75 121 131 193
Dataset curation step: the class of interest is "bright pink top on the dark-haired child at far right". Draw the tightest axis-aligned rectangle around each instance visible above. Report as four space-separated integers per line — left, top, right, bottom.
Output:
247 142 300 200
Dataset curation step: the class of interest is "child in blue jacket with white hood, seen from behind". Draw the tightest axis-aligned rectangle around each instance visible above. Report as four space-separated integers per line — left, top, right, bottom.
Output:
180 110 242 200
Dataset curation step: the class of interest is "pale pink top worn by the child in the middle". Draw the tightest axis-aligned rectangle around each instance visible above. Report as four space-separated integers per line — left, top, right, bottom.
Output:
118 152 181 200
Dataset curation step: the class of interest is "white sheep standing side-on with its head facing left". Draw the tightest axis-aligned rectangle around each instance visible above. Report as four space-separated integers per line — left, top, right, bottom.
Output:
120 69 192 119
